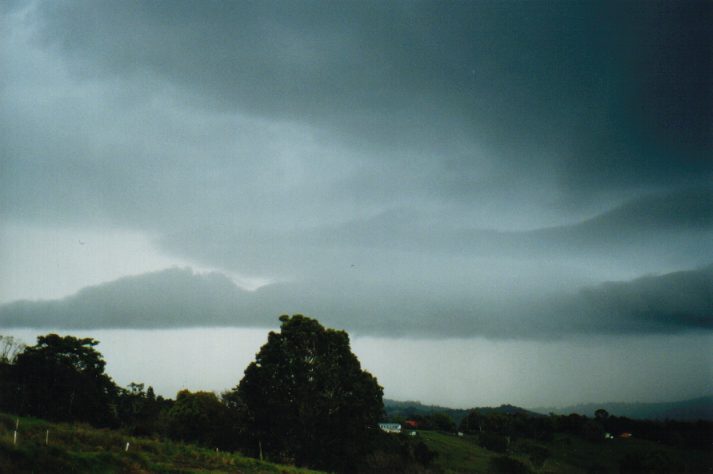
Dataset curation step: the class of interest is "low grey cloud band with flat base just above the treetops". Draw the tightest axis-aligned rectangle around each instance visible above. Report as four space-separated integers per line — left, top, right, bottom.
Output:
0 265 713 339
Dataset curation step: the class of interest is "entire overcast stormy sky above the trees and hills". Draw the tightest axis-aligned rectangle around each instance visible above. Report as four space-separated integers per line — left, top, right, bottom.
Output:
0 0 713 406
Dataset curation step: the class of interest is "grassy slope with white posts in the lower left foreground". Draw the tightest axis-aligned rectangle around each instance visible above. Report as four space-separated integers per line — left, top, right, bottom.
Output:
0 414 314 473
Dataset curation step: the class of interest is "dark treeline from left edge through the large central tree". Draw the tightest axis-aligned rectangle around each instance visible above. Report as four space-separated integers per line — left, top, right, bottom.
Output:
0 315 434 472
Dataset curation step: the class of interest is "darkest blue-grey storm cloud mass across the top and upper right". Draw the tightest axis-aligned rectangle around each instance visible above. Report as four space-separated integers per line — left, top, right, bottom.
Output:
11 1 713 202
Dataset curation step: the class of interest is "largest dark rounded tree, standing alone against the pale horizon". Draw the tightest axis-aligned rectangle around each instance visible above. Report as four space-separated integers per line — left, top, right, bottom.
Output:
235 315 383 471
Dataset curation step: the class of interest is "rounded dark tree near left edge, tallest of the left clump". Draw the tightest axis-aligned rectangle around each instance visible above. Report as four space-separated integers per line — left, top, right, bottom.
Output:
13 334 117 426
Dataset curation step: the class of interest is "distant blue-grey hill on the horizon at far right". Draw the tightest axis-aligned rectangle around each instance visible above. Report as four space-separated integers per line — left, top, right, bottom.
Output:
533 395 713 421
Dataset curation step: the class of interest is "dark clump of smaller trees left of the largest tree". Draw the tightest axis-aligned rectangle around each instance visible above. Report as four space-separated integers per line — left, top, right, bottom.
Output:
0 334 225 444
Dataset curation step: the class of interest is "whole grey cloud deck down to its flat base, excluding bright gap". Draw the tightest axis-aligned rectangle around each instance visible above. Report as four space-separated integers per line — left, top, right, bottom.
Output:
0 1 713 336
